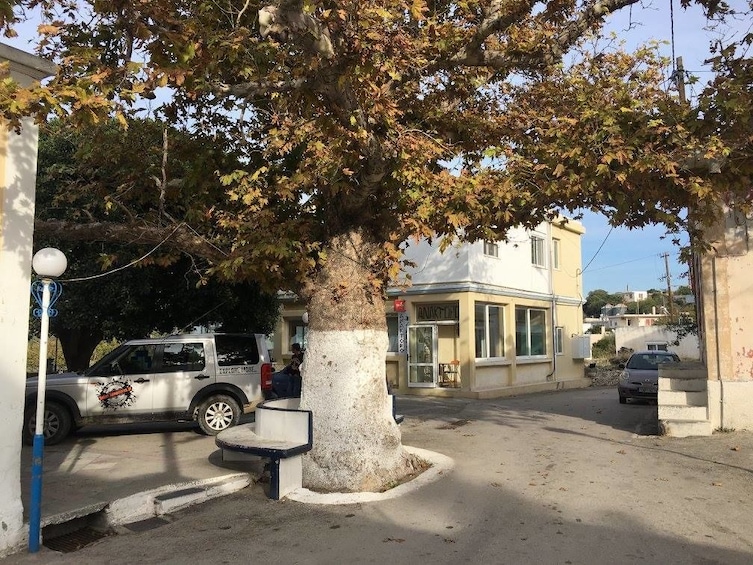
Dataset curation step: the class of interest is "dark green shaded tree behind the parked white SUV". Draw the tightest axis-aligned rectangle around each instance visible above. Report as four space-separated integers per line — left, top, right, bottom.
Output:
36 120 279 370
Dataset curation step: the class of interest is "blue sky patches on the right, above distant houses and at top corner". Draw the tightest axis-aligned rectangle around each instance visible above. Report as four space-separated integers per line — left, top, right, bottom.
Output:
582 0 751 295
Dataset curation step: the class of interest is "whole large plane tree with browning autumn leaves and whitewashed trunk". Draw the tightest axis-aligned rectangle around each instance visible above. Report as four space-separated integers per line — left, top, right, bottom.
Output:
0 0 748 491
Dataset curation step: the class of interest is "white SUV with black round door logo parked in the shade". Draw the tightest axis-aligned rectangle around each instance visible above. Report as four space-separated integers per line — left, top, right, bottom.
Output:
23 334 272 445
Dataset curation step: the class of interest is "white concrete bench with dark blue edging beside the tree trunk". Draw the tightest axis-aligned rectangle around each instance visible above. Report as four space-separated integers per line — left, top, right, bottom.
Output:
215 398 313 500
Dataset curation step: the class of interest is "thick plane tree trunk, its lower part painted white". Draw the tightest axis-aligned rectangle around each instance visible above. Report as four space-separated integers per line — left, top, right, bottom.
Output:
301 234 415 492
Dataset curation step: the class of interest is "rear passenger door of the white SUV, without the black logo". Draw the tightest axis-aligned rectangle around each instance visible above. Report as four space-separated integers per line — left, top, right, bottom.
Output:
151 338 215 415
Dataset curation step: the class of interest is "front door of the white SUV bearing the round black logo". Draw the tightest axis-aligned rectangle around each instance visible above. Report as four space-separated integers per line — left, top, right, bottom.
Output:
82 344 158 418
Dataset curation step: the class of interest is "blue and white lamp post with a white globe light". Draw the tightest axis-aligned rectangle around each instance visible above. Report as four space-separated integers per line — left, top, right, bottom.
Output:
29 247 68 553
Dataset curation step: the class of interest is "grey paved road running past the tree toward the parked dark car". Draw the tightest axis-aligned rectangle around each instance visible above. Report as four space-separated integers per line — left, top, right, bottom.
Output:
5 388 753 565
